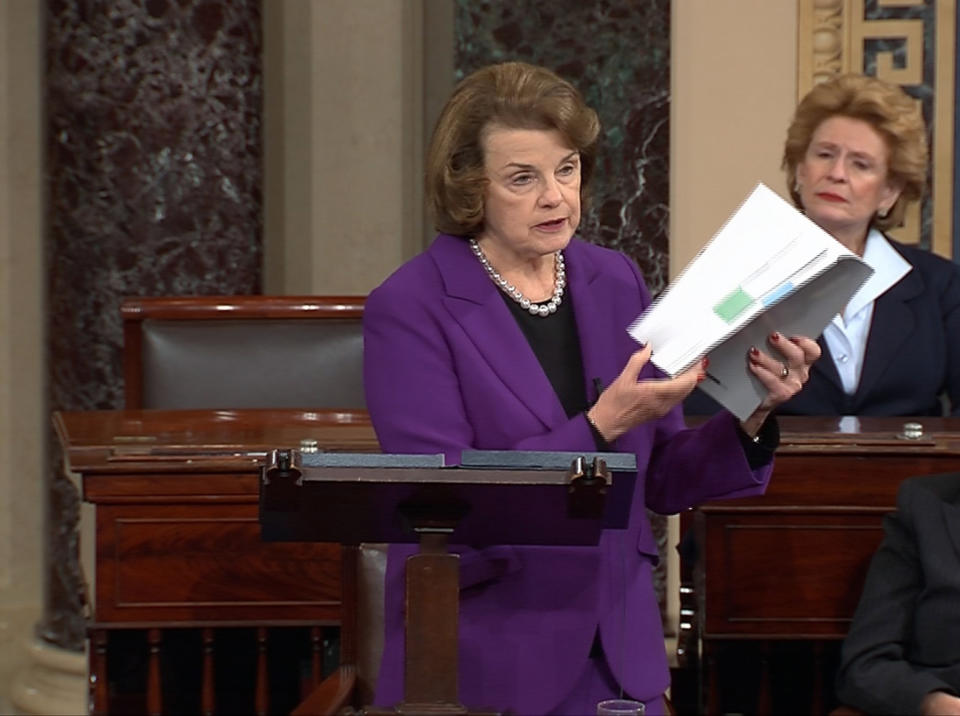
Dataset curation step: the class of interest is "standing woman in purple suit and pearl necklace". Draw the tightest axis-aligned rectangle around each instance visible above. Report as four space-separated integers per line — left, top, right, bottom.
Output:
364 63 819 714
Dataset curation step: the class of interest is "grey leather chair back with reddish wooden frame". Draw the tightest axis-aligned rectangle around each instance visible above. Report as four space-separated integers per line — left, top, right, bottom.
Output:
121 296 366 410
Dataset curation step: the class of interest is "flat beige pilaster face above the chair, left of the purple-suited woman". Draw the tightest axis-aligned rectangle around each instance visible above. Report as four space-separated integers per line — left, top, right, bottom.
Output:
311 0 413 293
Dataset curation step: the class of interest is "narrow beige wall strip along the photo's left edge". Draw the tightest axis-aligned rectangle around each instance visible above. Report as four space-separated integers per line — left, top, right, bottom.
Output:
0 0 47 608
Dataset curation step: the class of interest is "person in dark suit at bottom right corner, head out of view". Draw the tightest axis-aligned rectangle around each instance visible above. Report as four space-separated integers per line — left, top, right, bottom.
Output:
837 472 960 714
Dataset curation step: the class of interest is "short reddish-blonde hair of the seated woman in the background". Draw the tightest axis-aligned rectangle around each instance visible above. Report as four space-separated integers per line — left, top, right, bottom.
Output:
782 74 928 230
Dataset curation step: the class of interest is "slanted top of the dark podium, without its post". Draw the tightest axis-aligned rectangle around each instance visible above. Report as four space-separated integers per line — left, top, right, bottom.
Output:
260 450 636 546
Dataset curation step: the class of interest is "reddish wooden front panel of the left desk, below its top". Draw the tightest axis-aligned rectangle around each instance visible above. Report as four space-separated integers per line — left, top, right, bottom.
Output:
95 503 341 623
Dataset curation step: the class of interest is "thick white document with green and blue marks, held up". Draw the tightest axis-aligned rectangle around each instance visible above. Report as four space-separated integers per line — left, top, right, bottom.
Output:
628 184 873 420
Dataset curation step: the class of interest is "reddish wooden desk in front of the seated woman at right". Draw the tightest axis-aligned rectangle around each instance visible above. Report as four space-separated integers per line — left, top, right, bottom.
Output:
693 418 960 713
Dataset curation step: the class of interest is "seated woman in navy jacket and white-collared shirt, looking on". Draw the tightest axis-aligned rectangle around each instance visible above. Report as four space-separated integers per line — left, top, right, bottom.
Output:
686 75 960 416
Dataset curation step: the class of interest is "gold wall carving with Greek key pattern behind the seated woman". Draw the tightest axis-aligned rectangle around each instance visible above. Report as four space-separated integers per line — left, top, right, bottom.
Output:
797 0 956 257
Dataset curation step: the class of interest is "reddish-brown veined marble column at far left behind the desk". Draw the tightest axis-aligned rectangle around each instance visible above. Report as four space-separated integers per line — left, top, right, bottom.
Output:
45 0 262 648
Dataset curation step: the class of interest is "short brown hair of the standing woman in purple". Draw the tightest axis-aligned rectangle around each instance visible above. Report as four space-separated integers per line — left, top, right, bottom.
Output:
426 62 600 236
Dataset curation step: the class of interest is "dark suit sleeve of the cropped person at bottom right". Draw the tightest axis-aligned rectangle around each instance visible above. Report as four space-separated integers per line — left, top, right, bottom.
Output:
837 480 952 714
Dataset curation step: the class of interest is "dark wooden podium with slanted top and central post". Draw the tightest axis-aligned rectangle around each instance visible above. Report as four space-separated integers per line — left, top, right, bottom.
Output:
260 450 637 714
